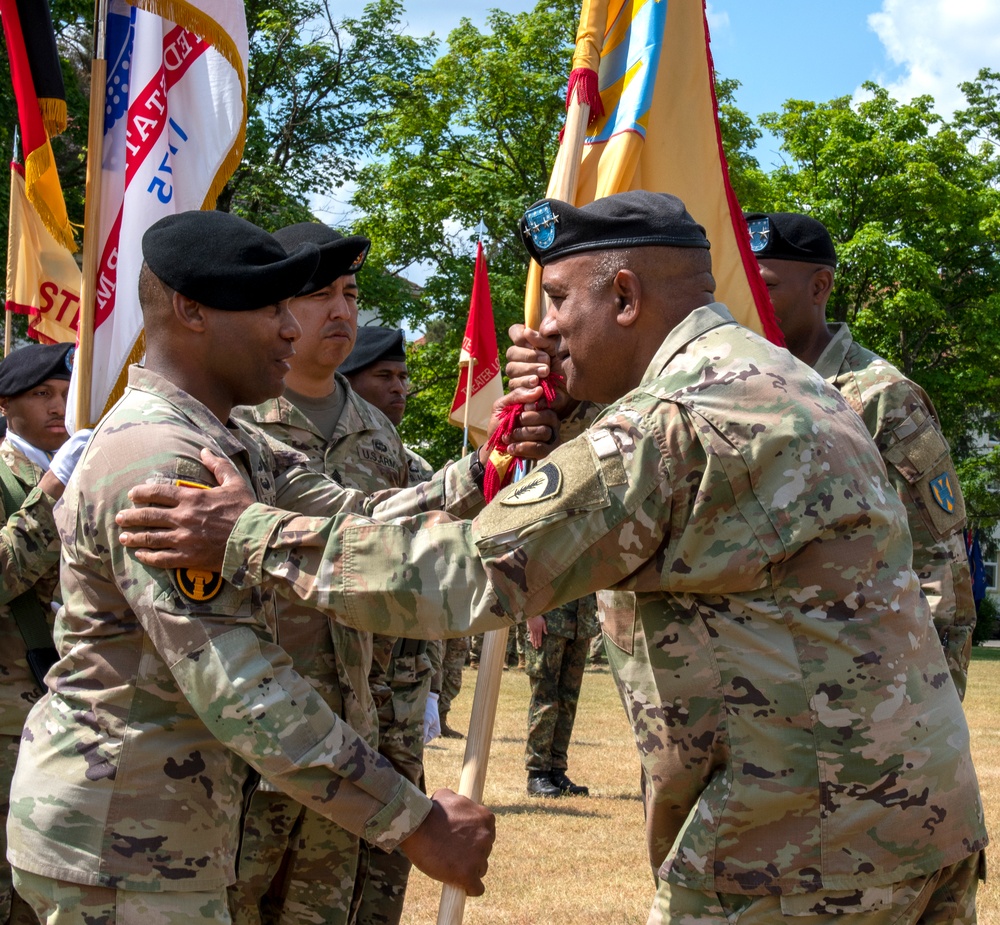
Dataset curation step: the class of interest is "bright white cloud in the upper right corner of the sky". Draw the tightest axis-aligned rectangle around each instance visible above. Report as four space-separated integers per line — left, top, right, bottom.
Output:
868 0 1000 118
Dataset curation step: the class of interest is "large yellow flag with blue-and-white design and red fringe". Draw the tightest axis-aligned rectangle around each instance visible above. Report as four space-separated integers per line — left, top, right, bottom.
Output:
533 0 783 343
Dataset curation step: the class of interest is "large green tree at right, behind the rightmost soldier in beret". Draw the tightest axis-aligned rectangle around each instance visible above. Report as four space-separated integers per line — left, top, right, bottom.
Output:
753 82 1000 456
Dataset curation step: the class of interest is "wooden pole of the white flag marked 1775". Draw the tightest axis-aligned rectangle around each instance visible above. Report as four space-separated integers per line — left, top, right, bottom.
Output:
74 0 108 430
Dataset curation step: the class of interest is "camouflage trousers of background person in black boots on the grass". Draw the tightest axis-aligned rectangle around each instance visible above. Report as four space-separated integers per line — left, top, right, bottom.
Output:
524 633 590 771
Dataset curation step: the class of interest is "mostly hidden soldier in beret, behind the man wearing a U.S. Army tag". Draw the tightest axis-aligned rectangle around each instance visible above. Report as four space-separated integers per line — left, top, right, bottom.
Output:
341 325 440 925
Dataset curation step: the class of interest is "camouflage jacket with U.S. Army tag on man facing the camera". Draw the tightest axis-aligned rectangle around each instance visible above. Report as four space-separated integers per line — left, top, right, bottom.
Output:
236 375 407 760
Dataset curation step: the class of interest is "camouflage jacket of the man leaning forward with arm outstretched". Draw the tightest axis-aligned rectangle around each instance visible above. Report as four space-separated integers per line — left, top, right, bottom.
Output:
224 304 987 894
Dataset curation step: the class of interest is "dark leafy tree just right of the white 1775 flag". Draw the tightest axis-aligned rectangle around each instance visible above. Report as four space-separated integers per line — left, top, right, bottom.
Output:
218 0 435 228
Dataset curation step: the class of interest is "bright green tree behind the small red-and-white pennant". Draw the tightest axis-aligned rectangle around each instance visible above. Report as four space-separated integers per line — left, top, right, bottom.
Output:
353 0 578 464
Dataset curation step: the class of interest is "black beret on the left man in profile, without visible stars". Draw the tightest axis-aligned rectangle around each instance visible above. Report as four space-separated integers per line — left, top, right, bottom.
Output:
142 211 319 312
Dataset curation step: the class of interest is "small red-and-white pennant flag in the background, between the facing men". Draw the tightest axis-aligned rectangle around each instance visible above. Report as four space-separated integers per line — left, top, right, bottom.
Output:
448 241 503 446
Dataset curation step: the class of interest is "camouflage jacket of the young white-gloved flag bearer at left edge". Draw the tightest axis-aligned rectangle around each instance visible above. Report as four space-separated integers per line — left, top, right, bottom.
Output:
0 440 59 736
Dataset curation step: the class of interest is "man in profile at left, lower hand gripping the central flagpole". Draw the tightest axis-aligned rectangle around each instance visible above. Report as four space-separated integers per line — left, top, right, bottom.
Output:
8 212 492 925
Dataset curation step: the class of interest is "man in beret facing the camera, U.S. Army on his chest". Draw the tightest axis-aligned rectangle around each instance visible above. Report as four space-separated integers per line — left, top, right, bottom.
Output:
229 222 418 925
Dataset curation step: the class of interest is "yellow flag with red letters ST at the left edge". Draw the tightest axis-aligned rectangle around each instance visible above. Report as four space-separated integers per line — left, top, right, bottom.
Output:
6 164 80 344
